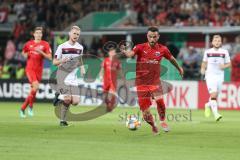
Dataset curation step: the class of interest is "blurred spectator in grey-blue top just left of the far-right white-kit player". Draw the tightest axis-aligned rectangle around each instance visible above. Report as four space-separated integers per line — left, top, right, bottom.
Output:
179 46 201 79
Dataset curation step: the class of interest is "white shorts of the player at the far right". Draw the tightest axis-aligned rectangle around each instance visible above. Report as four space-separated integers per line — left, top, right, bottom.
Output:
206 75 224 94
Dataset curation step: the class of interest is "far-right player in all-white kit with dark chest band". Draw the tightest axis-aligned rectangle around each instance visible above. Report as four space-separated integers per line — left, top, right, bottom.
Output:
201 35 231 121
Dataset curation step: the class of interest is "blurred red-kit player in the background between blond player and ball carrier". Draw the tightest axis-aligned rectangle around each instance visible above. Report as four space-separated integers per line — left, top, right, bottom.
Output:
100 48 123 111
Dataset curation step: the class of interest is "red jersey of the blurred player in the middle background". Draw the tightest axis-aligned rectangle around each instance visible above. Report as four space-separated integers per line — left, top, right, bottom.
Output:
102 57 121 85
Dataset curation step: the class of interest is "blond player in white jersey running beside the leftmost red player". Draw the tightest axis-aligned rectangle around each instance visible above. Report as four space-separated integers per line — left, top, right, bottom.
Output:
53 26 85 126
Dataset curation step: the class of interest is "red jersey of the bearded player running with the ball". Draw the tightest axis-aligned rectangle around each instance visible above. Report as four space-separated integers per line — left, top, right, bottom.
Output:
133 43 172 86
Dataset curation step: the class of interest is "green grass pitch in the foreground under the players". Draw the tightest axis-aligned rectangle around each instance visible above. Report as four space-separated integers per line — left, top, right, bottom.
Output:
0 103 240 160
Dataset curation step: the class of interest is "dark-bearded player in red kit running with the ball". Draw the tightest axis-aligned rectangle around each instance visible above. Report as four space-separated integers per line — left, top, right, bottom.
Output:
120 27 184 134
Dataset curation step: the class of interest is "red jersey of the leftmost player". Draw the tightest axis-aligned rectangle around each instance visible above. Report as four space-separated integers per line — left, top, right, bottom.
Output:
23 40 52 72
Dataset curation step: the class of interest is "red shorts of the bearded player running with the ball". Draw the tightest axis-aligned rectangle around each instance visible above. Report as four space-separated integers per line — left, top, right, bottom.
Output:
137 85 162 111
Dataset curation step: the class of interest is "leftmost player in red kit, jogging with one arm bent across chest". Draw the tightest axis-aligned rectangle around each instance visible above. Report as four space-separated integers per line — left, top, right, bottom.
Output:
20 27 52 118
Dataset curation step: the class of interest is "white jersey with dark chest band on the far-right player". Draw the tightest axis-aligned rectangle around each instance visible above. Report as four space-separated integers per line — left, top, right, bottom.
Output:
203 48 230 76
